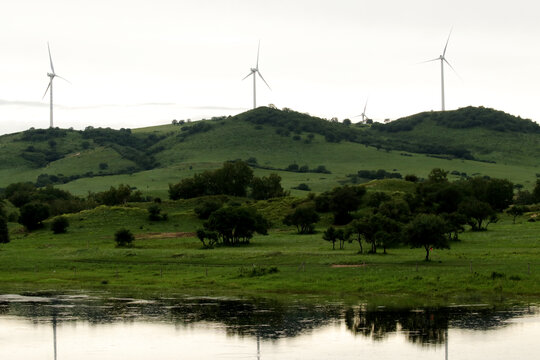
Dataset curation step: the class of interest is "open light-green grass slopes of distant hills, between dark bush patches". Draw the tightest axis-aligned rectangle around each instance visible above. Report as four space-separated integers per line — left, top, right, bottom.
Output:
0 108 540 198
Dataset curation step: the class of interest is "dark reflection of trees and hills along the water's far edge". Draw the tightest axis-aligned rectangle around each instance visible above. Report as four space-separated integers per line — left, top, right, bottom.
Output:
0 295 538 345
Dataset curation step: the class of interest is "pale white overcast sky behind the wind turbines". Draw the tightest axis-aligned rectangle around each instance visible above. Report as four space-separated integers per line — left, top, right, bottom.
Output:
0 0 540 134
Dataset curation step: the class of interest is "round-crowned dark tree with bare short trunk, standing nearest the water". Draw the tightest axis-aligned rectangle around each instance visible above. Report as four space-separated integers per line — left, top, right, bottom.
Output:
405 214 450 261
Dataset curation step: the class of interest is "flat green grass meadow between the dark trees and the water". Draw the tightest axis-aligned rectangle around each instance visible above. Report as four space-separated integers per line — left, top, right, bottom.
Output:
0 201 540 305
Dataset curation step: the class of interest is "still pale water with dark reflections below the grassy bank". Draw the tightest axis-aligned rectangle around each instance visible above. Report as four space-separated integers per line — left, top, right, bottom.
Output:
0 295 540 360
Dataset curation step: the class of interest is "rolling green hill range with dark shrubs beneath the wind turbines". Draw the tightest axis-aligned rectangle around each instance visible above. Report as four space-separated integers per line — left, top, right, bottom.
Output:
0 107 540 197
